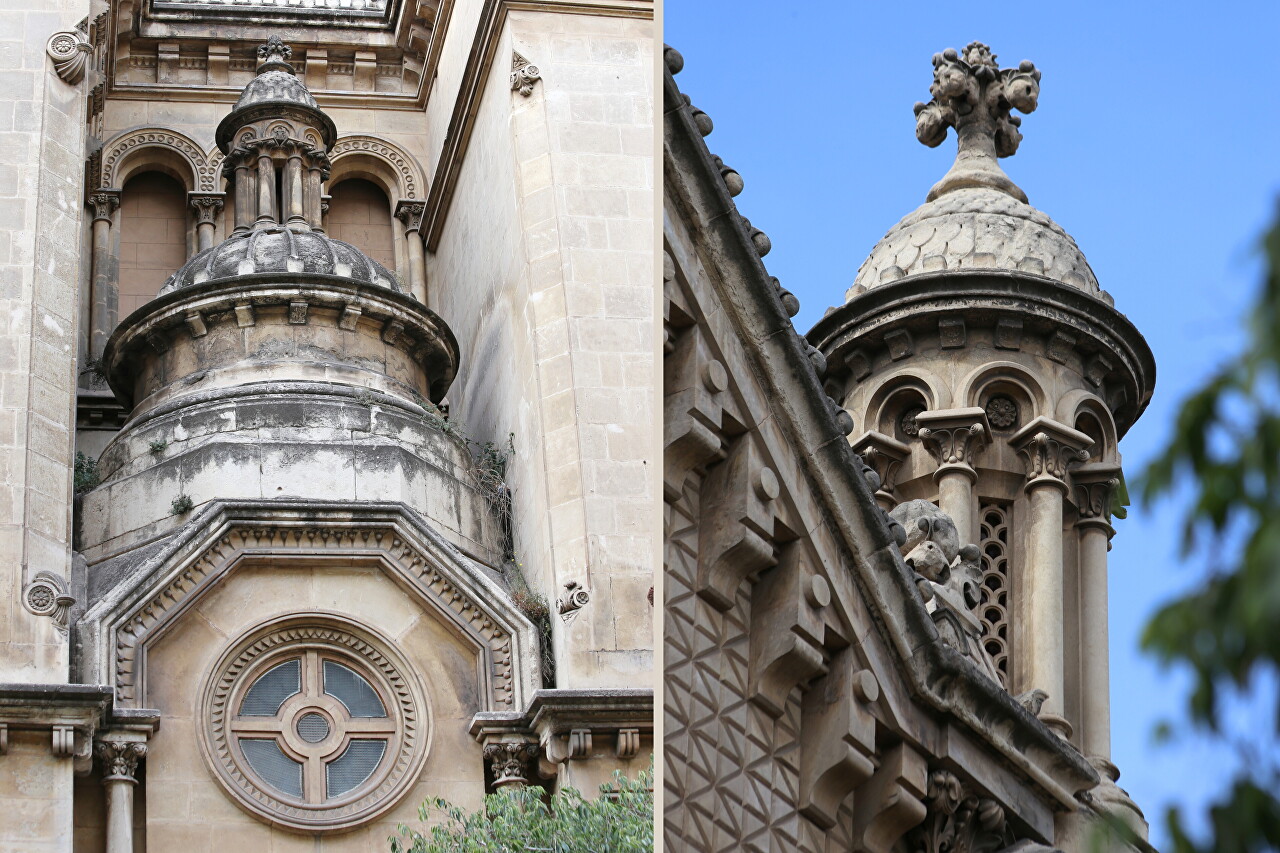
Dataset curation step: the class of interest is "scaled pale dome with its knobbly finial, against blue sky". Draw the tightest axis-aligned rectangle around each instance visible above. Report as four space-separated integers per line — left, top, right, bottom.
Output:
846 42 1101 300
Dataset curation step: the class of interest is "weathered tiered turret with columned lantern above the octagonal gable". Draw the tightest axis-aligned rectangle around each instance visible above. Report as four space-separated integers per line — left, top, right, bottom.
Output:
81 37 502 561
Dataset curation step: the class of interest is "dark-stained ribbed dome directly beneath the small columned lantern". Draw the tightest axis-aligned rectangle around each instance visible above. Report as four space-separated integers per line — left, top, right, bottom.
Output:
160 225 404 295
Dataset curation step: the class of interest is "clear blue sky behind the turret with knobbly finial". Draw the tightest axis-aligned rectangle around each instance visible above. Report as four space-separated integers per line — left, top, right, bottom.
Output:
664 0 1280 845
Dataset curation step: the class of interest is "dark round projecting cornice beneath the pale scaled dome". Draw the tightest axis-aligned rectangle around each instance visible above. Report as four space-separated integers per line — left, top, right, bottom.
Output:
805 270 1156 437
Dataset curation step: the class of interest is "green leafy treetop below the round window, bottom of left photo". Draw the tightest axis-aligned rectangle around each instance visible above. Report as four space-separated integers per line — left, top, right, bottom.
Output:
389 762 653 853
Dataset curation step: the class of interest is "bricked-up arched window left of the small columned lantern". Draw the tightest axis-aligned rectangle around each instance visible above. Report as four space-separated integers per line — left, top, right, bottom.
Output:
118 172 189 320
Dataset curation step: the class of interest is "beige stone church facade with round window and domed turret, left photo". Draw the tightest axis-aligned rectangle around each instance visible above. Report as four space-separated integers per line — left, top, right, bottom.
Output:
0 0 658 853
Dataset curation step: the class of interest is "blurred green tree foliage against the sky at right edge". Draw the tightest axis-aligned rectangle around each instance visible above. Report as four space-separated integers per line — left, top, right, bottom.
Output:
1142 213 1280 853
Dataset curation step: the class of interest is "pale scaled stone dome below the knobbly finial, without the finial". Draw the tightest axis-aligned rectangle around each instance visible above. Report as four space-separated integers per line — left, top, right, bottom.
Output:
849 187 1101 298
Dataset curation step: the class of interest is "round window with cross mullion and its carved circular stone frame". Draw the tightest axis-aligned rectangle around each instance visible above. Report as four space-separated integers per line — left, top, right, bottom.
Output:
202 617 430 830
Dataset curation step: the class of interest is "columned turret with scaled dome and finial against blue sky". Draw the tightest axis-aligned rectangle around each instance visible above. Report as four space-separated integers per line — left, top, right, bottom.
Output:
808 42 1155 799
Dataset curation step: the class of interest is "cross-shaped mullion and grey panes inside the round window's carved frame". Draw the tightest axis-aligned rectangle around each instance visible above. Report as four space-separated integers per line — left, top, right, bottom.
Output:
230 651 397 806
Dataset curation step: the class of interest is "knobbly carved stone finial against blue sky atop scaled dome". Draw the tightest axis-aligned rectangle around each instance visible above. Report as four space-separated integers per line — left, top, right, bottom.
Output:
915 41 1041 202
